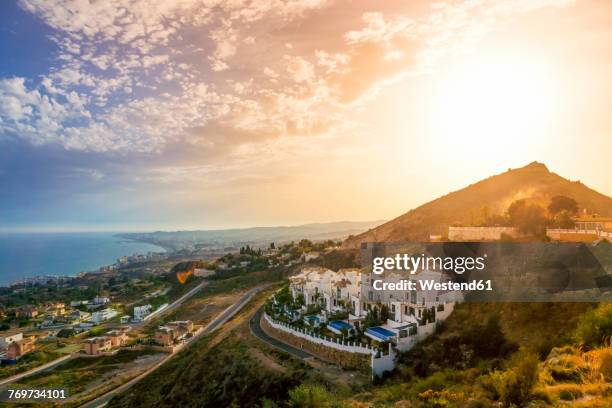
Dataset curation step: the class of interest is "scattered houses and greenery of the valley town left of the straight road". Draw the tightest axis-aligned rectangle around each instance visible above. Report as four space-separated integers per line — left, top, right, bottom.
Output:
0 236 340 400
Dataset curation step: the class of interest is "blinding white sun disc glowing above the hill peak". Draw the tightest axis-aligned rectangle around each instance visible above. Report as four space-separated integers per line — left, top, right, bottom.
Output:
428 57 558 153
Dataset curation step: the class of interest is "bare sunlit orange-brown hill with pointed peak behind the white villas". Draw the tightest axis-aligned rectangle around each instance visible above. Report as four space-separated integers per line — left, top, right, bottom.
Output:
343 162 612 248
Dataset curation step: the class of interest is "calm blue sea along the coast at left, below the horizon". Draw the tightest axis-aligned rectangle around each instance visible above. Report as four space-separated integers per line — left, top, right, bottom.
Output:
0 232 164 286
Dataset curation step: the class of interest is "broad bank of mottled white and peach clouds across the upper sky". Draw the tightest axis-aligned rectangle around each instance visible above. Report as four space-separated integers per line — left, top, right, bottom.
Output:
0 0 569 158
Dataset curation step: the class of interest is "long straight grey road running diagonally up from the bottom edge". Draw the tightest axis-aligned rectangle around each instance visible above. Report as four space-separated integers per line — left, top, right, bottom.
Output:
80 286 264 408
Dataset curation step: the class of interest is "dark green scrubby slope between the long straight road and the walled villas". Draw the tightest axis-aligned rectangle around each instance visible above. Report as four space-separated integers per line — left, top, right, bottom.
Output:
109 337 306 407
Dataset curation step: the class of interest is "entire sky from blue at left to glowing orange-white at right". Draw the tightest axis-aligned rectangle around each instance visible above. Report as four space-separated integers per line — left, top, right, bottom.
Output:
0 0 612 231
